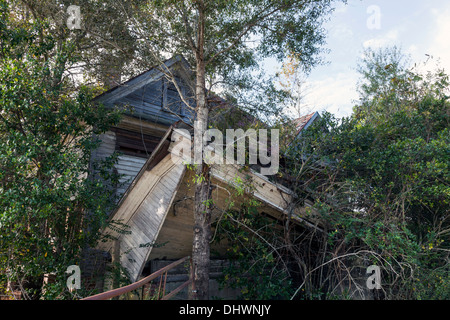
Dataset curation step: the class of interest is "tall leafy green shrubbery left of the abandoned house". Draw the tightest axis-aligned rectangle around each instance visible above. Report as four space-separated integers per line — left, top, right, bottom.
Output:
0 1 119 298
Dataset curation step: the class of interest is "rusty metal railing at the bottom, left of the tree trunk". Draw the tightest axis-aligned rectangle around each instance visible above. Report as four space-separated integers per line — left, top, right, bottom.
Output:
81 256 192 300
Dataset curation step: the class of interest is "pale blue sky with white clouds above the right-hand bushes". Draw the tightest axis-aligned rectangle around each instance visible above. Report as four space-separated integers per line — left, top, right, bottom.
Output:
284 0 450 118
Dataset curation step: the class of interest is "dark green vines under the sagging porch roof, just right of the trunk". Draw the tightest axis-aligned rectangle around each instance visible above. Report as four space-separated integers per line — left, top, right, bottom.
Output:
214 177 293 300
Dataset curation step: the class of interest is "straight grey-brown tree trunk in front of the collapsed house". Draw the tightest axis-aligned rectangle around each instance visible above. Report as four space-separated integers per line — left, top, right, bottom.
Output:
190 1 211 300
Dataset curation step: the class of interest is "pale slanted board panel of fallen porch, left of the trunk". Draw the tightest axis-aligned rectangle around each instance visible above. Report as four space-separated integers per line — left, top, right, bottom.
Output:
100 154 185 281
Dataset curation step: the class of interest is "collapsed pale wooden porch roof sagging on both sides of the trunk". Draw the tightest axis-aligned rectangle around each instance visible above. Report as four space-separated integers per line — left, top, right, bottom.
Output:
98 129 320 281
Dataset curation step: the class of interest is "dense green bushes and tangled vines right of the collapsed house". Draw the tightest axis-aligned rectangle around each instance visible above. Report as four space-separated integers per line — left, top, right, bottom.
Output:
289 51 450 299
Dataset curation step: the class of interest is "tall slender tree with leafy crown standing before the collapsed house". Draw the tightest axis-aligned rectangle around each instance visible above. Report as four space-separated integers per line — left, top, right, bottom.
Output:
126 0 344 299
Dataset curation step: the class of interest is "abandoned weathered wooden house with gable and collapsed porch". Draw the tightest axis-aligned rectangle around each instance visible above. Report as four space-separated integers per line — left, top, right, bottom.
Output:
86 57 324 296
